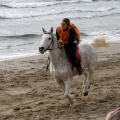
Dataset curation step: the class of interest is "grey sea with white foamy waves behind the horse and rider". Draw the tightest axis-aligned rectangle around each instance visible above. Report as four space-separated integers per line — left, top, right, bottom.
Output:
0 0 120 61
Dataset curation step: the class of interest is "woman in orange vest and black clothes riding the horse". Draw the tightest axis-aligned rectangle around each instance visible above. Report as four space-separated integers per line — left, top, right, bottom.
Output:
56 18 83 75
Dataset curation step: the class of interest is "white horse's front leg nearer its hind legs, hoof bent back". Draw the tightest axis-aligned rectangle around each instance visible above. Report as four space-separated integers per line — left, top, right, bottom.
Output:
64 78 78 105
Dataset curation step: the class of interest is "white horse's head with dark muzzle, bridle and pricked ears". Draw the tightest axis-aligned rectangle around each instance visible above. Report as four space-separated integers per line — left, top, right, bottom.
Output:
39 28 54 54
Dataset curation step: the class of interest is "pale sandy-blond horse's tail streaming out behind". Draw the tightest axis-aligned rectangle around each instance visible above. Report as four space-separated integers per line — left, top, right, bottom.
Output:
90 38 110 47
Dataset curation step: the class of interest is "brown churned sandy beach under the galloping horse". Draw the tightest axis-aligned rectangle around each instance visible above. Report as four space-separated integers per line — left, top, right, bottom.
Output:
0 43 120 120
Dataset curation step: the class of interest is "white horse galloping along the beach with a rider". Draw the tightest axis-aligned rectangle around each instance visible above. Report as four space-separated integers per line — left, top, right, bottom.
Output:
39 28 106 104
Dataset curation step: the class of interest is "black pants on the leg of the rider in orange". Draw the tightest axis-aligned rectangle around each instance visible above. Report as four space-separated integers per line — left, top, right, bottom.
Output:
64 43 81 68
